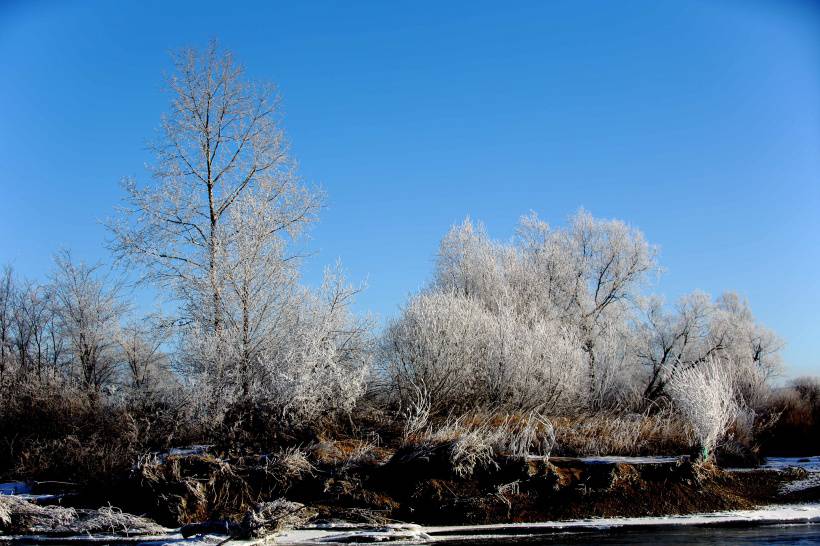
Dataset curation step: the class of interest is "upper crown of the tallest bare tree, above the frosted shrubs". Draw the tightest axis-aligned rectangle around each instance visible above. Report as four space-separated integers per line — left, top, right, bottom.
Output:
110 40 320 333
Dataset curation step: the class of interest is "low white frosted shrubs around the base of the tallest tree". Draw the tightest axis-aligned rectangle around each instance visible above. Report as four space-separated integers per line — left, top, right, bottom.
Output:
181 268 373 423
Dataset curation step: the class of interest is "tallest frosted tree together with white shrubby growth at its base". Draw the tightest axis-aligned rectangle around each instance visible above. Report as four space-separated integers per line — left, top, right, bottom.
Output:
111 45 371 414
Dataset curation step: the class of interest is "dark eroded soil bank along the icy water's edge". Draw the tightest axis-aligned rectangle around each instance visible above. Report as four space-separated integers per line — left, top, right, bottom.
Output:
76 443 820 526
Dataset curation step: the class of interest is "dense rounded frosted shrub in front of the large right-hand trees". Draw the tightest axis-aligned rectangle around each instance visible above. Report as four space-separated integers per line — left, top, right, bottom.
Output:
382 293 584 413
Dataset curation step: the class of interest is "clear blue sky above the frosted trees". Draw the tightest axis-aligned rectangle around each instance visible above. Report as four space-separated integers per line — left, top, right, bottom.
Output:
0 0 820 375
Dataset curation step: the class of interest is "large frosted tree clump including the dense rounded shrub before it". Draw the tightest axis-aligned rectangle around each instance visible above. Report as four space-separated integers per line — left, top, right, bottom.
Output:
383 211 655 408
